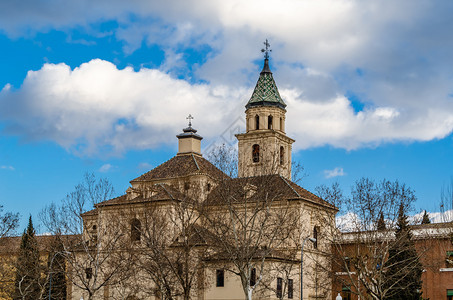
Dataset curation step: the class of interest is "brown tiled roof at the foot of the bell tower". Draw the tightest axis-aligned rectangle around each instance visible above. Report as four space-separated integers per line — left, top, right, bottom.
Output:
207 175 335 209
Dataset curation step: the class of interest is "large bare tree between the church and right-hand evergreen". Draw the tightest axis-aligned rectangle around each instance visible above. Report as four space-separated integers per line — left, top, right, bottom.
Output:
317 178 420 299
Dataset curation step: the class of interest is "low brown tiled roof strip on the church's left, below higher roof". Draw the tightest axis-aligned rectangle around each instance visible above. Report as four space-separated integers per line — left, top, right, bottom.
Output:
96 183 186 207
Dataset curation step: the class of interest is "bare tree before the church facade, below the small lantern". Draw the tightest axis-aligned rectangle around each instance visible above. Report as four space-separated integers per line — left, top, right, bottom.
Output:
132 182 207 299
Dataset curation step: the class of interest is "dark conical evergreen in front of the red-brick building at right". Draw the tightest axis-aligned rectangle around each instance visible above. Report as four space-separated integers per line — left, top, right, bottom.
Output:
385 205 423 300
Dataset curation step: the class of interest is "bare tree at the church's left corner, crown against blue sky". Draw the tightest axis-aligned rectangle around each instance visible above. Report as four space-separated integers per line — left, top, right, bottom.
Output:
40 174 131 299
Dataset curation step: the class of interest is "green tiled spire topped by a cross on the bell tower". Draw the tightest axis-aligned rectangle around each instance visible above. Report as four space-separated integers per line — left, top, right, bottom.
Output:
245 40 286 109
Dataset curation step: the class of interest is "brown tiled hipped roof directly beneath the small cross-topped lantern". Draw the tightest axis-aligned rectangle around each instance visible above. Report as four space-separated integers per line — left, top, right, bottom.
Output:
131 154 227 182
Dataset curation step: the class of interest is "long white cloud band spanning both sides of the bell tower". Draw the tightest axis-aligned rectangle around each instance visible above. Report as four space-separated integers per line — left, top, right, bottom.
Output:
0 59 453 156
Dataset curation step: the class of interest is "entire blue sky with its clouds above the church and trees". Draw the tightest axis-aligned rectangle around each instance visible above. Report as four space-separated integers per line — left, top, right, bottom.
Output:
0 0 453 230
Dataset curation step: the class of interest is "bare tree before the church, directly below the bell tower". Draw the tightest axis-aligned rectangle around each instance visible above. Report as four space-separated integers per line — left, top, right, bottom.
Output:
204 175 300 299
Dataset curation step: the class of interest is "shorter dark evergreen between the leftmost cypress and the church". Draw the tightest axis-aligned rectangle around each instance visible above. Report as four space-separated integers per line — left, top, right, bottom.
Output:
45 235 66 300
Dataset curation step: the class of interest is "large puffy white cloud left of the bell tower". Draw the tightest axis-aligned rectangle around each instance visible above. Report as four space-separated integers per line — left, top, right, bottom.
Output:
0 59 247 156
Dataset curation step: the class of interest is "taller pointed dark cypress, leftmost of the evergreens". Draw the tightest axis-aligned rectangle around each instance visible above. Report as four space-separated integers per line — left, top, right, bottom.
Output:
14 216 41 300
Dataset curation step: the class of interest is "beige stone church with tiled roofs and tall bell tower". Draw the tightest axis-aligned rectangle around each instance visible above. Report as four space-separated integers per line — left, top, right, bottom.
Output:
69 43 337 300
